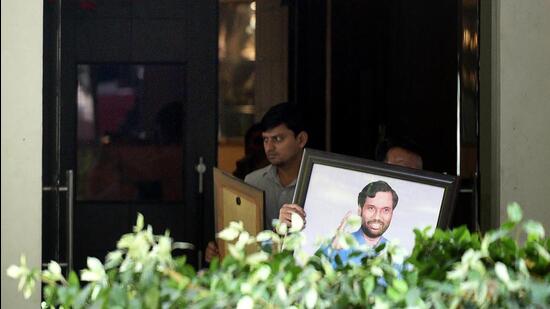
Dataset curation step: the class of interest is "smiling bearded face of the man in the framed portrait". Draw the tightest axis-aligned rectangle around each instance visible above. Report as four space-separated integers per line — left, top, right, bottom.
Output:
360 192 393 238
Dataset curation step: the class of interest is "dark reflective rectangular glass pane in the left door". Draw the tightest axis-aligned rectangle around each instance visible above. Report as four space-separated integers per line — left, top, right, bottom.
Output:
77 64 185 201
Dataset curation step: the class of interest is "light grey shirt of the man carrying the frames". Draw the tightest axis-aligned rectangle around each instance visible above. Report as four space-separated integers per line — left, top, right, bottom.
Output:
244 164 296 229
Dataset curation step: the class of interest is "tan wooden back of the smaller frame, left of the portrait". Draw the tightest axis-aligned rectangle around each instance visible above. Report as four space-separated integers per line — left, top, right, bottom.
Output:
213 167 265 258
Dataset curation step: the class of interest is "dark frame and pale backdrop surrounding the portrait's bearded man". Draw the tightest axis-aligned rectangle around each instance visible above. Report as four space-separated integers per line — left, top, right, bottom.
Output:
293 149 458 254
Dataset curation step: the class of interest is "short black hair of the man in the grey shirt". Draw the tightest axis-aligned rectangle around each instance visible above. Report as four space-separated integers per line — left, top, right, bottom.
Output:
261 102 306 135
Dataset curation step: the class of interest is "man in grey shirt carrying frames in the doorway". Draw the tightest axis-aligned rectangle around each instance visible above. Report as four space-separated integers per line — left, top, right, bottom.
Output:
205 102 308 262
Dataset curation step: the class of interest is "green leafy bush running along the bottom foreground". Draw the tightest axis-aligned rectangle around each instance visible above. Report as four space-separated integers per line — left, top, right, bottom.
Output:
8 204 550 308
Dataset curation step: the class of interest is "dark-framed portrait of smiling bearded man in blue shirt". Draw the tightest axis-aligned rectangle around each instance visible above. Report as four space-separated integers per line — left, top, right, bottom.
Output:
293 149 457 259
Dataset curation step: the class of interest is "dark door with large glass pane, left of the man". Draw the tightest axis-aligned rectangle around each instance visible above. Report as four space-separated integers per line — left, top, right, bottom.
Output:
43 0 217 269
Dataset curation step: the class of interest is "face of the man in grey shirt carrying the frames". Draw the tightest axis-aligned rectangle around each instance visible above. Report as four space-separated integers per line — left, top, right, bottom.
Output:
262 124 305 166
